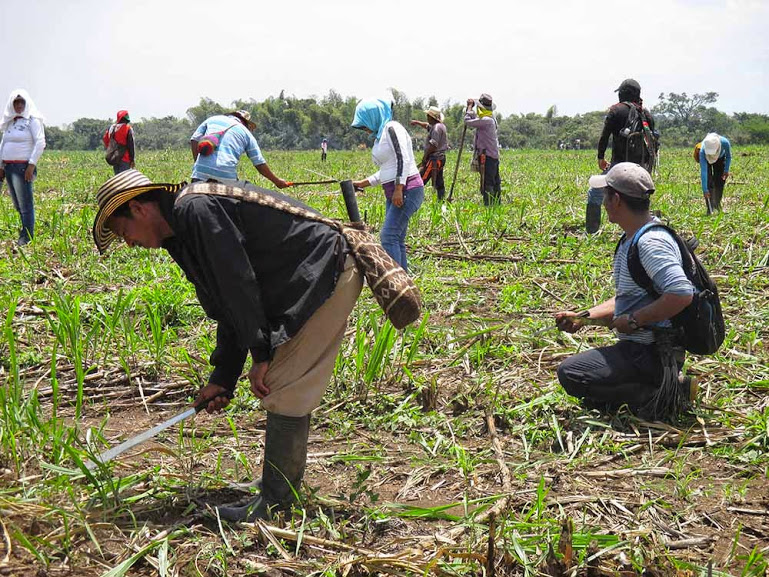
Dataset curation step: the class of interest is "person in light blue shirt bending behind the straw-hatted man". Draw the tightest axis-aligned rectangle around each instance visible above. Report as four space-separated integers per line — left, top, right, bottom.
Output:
190 110 288 188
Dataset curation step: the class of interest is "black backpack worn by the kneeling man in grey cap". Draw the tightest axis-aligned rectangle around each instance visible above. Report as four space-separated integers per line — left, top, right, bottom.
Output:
617 222 726 355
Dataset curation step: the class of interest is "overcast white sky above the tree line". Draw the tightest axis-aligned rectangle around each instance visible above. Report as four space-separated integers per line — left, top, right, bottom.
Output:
0 0 769 125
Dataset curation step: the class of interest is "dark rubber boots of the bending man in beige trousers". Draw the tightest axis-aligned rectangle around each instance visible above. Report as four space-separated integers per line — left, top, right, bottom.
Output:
219 413 310 523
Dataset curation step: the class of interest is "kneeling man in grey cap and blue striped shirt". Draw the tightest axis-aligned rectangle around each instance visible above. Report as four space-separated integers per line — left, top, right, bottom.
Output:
555 162 696 418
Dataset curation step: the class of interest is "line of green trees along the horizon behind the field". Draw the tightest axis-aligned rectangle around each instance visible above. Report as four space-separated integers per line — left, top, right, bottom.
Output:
40 89 769 150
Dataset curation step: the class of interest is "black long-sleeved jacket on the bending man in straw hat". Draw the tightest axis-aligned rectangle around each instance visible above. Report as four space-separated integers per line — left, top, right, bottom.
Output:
160 183 349 390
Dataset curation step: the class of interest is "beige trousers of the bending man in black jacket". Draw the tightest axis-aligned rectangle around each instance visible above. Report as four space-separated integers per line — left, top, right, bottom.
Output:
262 255 363 417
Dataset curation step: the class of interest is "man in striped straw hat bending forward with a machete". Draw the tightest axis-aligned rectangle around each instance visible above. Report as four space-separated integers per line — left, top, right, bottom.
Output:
93 170 362 521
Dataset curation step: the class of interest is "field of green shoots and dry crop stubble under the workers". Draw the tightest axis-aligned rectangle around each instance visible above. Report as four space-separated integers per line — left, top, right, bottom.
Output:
0 148 769 577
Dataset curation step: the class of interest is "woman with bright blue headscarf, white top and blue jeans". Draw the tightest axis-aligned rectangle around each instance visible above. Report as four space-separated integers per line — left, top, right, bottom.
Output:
352 100 425 271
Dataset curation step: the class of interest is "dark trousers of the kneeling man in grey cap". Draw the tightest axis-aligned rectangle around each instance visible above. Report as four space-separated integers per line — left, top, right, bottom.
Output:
558 340 684 411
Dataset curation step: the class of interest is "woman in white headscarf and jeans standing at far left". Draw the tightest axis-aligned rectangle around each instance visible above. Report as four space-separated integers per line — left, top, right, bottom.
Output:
0 88 45 245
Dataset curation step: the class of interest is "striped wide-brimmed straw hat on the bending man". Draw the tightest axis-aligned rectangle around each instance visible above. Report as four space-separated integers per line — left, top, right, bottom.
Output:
93 170 187 254
